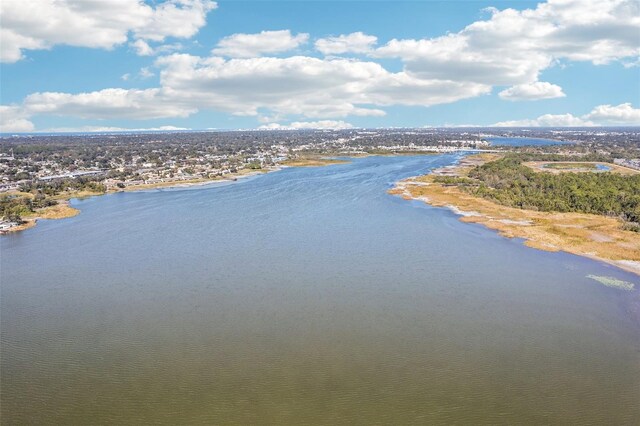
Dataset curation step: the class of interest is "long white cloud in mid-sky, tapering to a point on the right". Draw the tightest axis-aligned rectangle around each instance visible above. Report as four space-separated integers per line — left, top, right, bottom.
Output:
156 54 490 118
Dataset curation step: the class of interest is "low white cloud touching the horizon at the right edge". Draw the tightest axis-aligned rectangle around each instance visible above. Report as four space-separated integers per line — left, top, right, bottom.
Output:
494 103 640 127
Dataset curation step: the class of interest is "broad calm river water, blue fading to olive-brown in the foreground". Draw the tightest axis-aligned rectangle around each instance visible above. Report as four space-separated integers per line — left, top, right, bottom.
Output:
0 155 640 425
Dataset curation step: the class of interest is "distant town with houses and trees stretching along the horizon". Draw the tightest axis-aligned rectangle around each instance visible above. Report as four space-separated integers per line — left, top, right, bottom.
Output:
0 128 640 232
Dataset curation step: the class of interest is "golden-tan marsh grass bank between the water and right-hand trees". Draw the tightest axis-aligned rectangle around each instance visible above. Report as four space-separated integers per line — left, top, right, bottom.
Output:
389 154 640 276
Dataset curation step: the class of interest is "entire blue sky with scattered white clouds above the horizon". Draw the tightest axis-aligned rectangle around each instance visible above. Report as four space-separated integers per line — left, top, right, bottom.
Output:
0 0 640 133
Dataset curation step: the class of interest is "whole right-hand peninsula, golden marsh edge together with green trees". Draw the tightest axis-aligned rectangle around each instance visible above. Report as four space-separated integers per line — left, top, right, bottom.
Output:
389 154 640 275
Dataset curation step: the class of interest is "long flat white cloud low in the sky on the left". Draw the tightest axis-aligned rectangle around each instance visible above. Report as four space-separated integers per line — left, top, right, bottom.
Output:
23 89 196 119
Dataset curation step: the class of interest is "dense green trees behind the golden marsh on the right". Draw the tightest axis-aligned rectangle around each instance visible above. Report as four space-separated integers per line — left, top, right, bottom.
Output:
438 155 640 231
